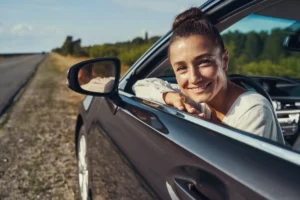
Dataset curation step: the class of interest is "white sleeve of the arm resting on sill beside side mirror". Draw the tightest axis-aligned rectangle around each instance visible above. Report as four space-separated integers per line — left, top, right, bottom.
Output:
132 78 181 104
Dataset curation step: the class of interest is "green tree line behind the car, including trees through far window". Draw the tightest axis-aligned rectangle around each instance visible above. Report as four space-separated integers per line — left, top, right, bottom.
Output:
53 28 300 78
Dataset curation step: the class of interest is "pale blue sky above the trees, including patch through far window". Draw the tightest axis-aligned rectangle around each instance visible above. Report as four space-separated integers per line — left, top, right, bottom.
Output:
0 0 291 53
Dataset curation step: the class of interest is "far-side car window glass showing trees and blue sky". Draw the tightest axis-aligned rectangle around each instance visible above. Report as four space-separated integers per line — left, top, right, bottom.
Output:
222 14 300 78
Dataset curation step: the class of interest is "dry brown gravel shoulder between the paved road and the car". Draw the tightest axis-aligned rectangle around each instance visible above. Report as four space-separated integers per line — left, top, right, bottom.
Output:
0 53 88 199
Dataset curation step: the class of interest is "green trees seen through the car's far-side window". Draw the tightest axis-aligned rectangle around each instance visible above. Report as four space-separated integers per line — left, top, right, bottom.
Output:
222 28 300 78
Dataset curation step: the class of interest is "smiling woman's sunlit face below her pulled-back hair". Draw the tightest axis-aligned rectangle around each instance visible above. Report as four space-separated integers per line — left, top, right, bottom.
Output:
170 35 228 103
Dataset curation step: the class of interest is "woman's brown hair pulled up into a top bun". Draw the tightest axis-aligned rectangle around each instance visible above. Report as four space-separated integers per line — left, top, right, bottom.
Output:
169 7 225 53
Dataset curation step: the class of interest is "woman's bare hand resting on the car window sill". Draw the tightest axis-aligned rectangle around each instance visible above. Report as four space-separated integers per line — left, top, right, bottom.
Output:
163 92 205 117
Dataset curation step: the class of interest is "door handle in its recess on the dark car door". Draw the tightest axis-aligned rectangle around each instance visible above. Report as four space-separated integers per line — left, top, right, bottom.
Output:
174 178 225 200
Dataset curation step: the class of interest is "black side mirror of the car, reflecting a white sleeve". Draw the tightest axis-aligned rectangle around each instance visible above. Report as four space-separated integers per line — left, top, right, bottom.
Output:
67 58 121 96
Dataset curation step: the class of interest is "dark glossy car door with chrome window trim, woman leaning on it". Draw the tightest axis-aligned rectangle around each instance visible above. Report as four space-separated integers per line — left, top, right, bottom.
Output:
91 1 300 199
